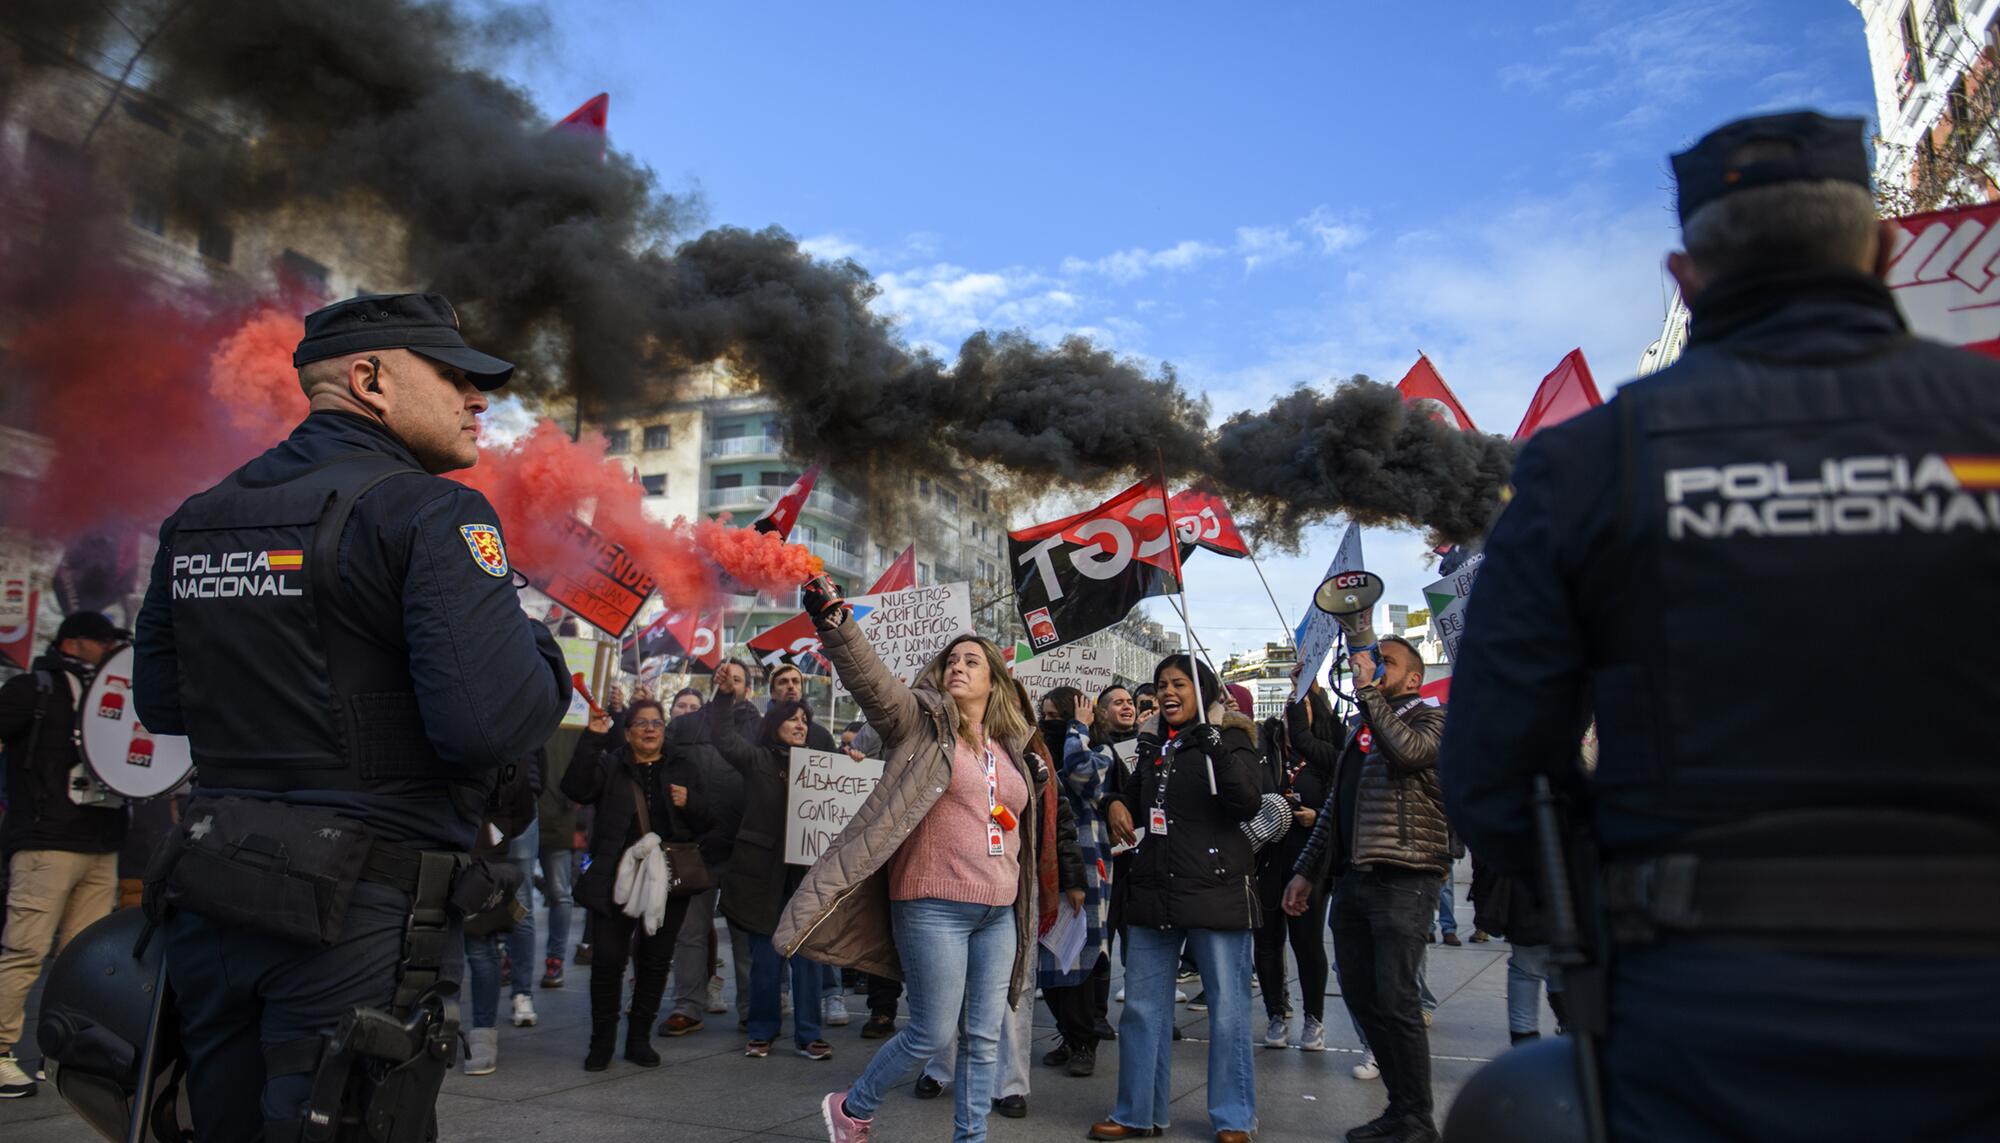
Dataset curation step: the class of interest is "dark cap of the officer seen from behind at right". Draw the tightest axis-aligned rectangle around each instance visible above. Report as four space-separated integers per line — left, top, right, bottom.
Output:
1674 112 1870 226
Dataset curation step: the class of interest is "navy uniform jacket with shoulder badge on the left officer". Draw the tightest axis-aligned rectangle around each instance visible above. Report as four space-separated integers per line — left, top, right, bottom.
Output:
134 412 570 849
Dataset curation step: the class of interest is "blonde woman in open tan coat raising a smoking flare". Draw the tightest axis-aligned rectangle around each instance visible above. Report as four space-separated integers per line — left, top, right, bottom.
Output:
772 575 1038 1143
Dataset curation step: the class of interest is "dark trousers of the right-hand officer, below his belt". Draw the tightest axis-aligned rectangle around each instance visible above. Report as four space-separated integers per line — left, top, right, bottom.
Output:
1602 941 2000 1143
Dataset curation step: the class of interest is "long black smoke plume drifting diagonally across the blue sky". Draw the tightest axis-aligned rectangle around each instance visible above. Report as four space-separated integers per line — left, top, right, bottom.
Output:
0 0 1506 542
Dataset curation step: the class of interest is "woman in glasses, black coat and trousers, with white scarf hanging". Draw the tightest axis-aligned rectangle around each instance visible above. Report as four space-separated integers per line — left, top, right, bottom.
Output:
562 699 696 1071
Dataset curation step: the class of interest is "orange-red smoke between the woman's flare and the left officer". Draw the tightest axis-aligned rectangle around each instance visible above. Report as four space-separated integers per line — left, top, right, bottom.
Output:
454 420 820 607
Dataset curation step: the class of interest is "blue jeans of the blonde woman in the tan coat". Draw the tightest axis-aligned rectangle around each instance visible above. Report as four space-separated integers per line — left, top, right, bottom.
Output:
844 897 1016 1143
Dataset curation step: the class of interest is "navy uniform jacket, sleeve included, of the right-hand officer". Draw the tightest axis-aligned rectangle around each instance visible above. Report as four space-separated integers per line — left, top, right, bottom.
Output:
1442 272 2000 871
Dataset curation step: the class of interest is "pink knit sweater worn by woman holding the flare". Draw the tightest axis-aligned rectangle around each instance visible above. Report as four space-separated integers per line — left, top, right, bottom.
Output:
888 739 1028 905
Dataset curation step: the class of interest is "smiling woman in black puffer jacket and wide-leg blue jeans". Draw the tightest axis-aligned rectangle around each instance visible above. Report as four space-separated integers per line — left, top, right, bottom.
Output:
1090 655 1264 1143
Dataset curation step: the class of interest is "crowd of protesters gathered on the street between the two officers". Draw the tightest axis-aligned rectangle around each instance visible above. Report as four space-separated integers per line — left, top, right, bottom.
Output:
0 599 1564 1143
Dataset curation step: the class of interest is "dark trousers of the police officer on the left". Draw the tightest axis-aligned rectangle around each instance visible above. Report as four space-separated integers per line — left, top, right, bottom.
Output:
166 881 462 1143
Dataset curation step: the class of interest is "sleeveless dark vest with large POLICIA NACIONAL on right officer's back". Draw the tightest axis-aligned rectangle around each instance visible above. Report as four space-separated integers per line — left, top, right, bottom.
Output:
1590 338 2000 841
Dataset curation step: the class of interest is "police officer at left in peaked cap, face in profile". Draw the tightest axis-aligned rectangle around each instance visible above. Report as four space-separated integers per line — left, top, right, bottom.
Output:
134 294 568 1143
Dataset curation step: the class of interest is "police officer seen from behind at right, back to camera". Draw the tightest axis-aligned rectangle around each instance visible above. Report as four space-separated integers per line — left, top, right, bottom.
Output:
1442 112 2000 1141
